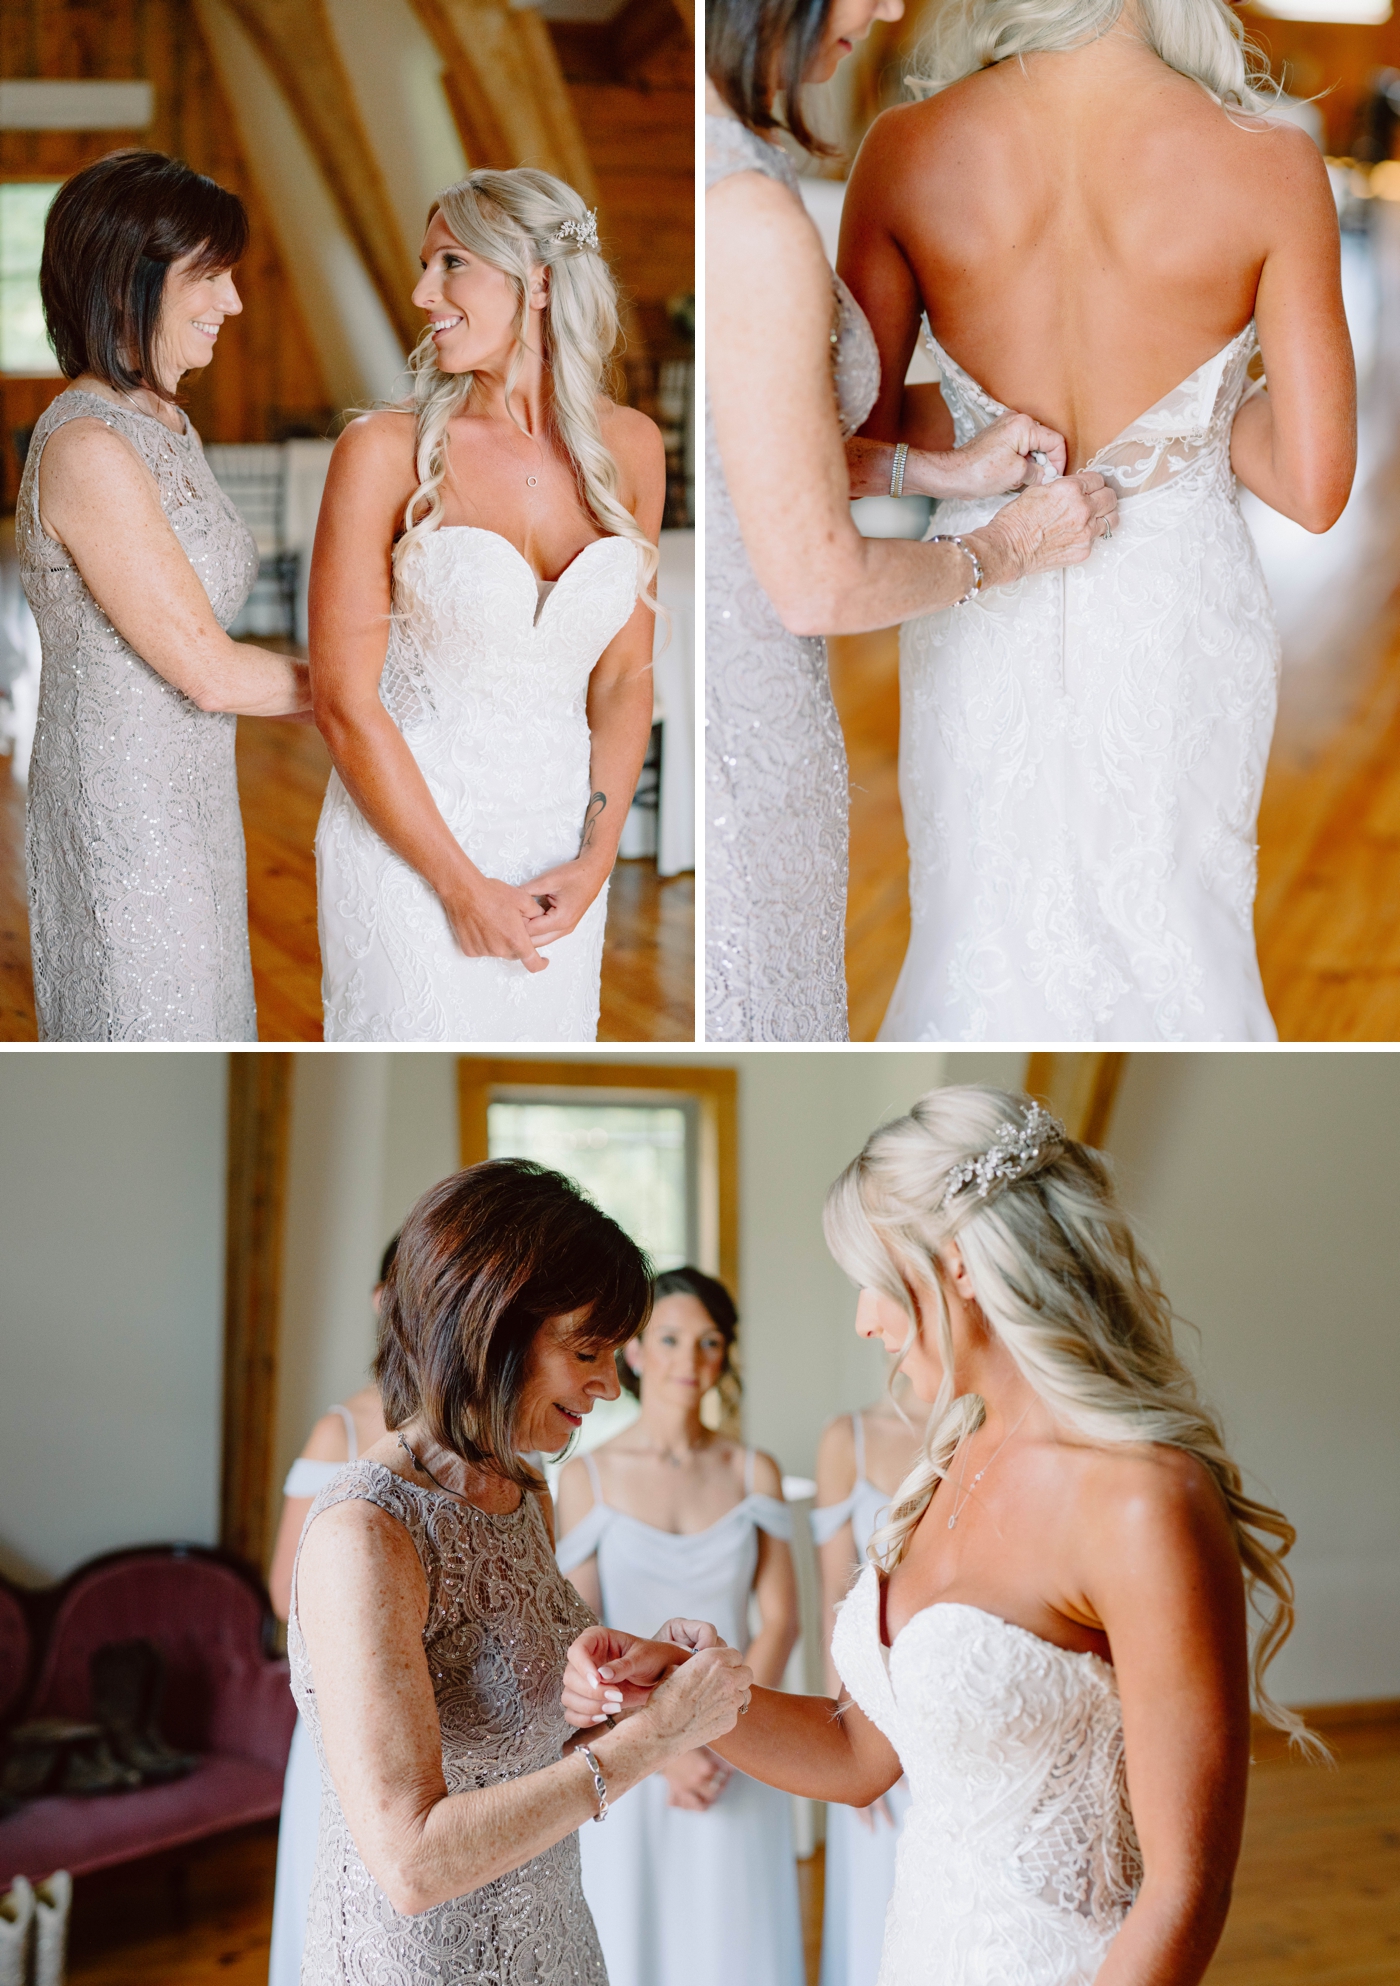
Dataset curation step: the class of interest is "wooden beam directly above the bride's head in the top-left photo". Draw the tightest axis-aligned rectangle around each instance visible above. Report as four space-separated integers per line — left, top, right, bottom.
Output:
411 0 598 207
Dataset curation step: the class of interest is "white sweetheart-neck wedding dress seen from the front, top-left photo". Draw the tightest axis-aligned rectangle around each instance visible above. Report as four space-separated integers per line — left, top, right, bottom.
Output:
316 524 639 1041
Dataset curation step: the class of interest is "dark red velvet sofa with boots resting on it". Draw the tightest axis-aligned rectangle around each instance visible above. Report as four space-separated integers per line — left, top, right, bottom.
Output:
0 1545 296 1891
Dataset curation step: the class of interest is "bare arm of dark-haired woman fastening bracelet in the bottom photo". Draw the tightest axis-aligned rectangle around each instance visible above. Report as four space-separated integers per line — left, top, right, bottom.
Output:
296 1499 749 1915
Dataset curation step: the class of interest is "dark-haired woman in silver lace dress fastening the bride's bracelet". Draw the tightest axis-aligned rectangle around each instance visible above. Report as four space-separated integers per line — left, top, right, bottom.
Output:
288 1158 753 1986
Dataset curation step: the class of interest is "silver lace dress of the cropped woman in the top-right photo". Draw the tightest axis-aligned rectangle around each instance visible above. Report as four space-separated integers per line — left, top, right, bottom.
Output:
705 117 880 1041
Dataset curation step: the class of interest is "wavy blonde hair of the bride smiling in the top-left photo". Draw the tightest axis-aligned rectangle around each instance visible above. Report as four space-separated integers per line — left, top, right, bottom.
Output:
393 165 657 610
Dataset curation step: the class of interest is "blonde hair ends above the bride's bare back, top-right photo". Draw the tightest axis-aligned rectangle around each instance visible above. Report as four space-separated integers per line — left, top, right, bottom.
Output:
906 0 1279 113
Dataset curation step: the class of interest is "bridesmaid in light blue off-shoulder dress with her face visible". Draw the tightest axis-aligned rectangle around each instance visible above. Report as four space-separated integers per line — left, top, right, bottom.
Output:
558 1269 804 1986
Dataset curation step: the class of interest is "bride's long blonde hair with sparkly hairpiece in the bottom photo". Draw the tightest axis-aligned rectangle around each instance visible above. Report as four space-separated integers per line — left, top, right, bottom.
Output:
824 1086 1325 1754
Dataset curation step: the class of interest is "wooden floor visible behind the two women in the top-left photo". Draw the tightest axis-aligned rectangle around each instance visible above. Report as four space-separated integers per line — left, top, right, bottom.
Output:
0 717 695 1041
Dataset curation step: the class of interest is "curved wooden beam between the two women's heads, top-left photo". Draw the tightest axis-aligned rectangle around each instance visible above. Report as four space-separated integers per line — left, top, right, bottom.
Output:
226 0 423 352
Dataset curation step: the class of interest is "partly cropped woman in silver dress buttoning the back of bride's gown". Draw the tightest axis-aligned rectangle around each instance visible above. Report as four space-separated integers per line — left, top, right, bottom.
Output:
705 0 1116 1041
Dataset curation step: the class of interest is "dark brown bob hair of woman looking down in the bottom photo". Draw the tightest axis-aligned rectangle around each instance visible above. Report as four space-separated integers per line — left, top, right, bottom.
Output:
373 1158 651 1490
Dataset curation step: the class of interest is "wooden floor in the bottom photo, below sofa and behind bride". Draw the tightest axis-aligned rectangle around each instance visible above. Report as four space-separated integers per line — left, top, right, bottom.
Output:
60 1722 1400 1986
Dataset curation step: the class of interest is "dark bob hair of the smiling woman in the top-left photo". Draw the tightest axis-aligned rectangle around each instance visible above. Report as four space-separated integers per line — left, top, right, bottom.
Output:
40 151 248 399
